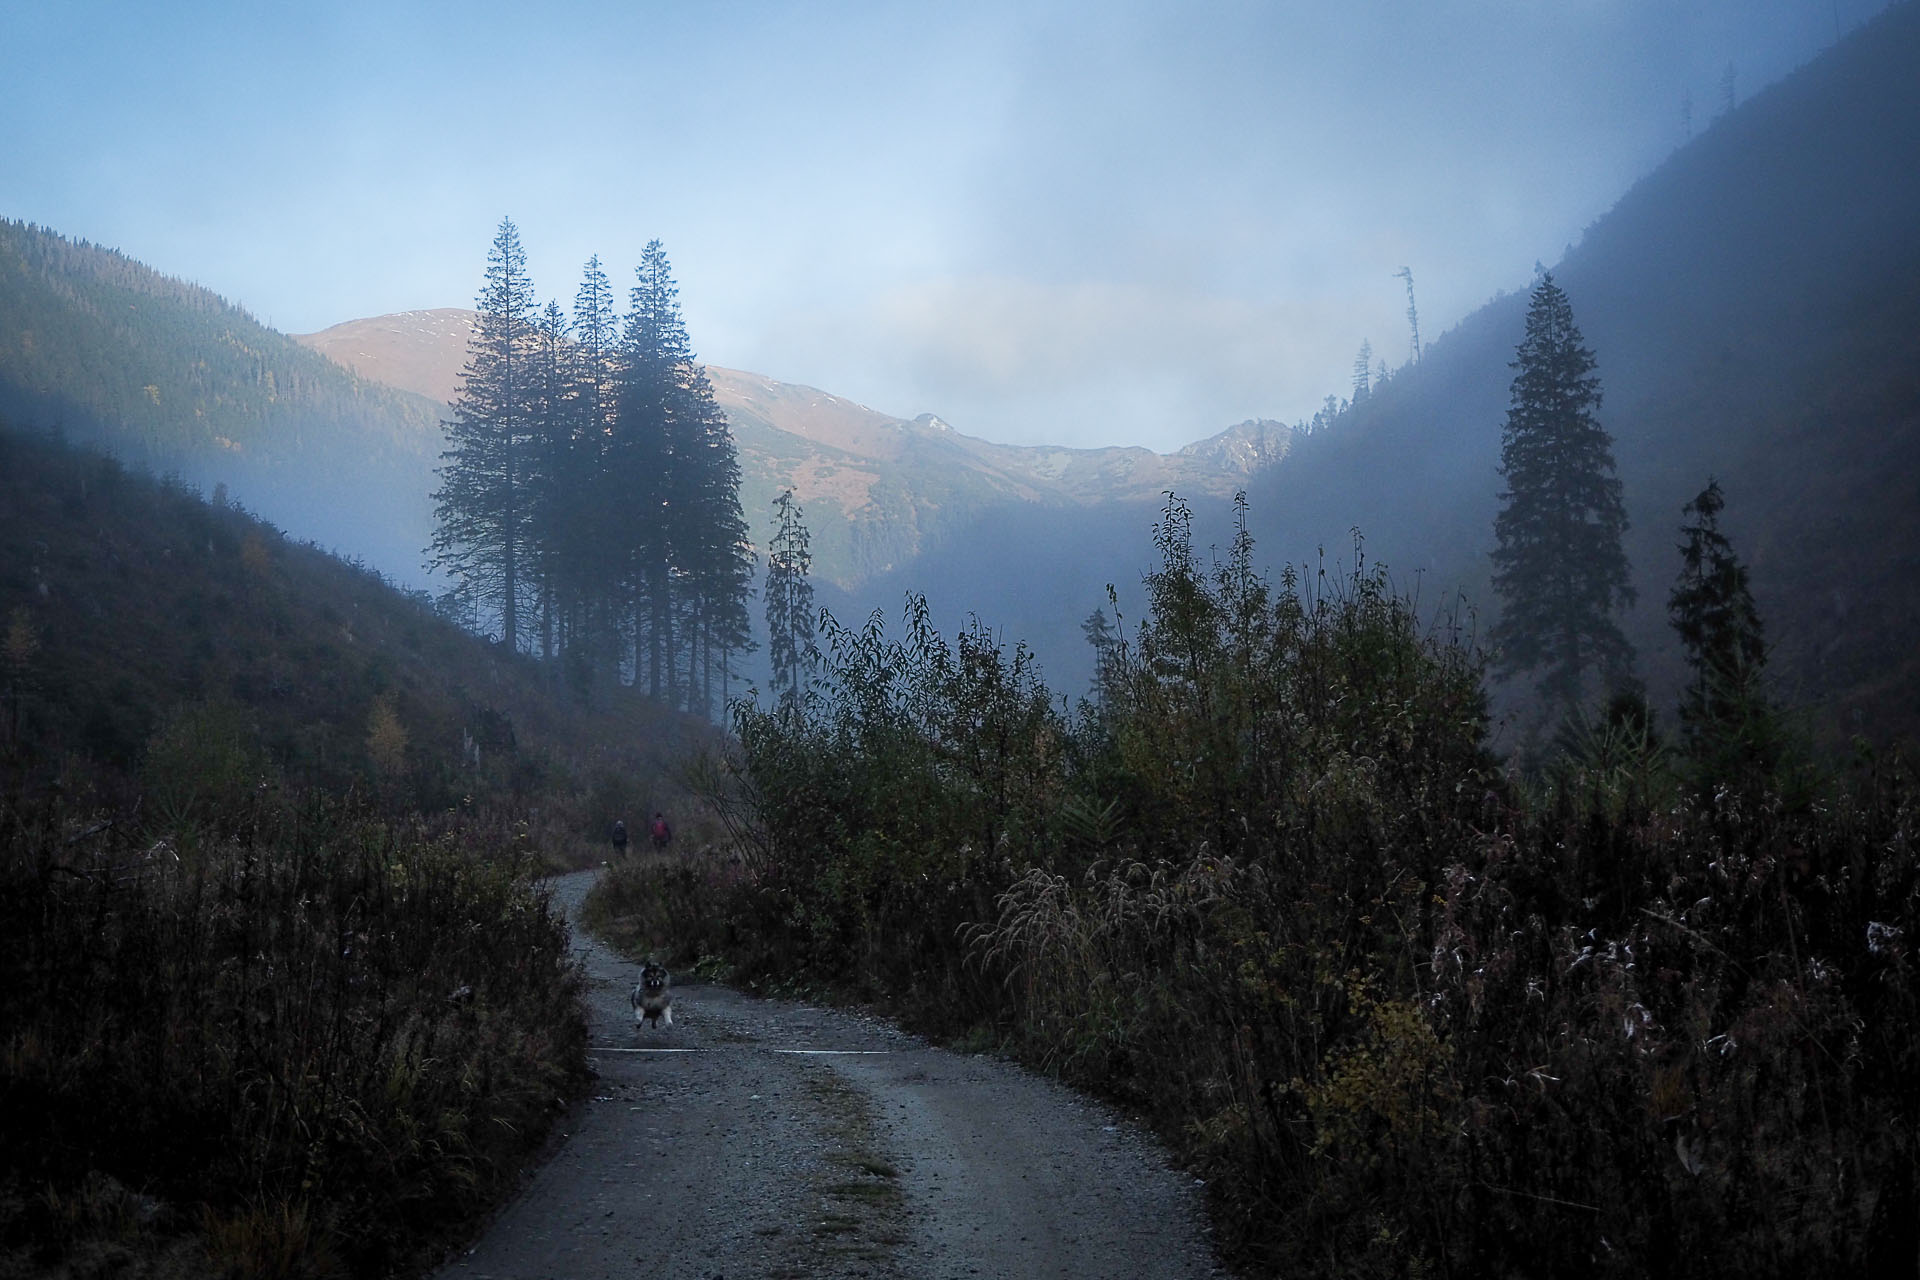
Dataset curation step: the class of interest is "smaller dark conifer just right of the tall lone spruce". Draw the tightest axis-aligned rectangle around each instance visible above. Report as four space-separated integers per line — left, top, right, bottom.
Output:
1667 480 1768 756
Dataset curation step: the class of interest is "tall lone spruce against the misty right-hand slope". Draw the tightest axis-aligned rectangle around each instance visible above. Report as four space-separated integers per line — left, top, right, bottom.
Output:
1492 274 1634 708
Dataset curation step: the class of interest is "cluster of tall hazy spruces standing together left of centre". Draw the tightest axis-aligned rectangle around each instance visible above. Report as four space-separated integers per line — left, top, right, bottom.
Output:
428 219 755 714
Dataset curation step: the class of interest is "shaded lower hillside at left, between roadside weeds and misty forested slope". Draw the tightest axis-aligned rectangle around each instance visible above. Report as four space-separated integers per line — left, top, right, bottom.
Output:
0 428 712 840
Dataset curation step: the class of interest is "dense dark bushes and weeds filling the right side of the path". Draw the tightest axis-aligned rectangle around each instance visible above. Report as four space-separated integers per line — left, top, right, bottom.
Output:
606 503 1920 1276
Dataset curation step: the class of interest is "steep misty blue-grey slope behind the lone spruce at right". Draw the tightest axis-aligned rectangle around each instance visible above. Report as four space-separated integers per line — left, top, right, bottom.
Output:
1254 2 1920 735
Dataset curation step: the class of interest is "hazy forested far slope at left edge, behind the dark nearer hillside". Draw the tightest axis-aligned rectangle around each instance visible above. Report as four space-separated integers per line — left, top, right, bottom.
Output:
0 221 444 578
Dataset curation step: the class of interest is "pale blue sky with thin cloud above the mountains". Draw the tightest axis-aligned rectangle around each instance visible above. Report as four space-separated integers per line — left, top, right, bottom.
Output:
0 0 1884 451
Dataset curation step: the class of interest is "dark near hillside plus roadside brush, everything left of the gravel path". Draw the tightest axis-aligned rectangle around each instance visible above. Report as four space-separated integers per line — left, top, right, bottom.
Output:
0 430 705 1276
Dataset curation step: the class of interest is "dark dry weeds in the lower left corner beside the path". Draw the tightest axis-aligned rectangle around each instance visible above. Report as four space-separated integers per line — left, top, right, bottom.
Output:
0 783 586 1276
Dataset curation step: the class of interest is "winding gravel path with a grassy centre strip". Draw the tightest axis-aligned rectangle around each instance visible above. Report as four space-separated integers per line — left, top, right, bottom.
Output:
438 871 1225 1280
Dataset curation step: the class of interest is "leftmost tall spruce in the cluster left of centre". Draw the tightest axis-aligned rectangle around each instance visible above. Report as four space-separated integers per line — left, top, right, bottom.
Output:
428 219 534 649
